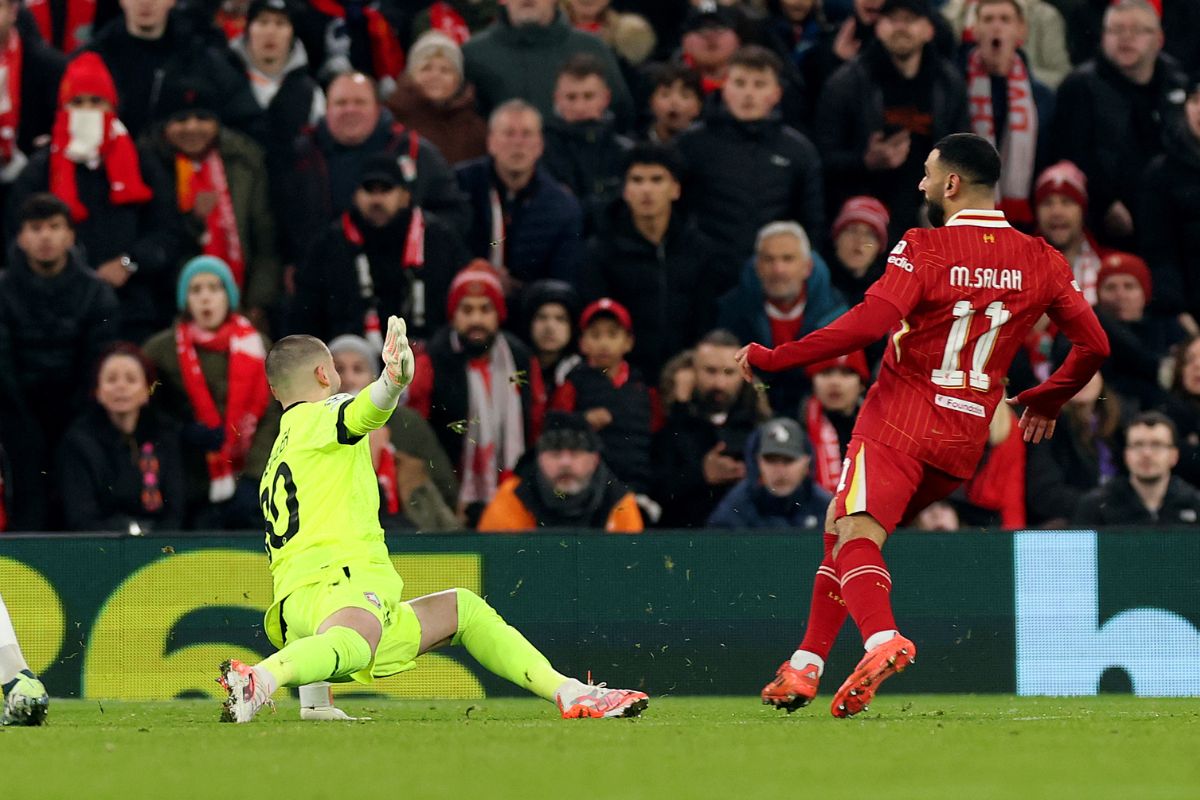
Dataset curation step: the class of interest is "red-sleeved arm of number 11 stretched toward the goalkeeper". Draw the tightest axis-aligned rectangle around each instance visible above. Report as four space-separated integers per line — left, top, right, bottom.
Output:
737 294 902 380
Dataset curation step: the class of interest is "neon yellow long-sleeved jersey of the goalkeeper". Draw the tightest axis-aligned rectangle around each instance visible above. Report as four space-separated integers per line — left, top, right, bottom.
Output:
258 391 391 600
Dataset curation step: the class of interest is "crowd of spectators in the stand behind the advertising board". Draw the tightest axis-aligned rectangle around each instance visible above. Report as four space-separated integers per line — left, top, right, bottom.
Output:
0 0 1200 533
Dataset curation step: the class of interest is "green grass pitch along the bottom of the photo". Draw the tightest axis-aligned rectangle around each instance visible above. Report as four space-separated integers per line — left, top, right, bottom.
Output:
0 696 1200 800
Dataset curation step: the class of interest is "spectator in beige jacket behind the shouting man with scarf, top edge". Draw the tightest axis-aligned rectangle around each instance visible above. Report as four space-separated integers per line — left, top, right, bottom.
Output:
942 0 1070 87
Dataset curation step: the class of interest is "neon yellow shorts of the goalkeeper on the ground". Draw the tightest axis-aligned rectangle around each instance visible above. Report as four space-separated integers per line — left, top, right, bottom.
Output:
263 561 421 684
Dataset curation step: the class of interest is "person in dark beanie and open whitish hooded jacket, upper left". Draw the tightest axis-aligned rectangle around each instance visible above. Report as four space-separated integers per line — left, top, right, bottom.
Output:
229 0 325 166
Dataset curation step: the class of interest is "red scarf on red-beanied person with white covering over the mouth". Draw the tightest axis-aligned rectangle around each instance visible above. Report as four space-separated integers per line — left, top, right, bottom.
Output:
50 108 154 222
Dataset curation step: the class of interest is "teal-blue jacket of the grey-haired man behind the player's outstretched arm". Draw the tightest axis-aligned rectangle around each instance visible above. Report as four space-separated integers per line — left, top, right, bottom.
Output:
716 251 847 416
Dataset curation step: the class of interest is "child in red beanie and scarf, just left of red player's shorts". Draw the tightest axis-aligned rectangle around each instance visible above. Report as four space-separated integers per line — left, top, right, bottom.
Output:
796 350 871 494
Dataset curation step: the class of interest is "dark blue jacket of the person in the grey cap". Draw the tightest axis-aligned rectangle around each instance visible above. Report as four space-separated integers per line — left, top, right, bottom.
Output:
708 432 833 529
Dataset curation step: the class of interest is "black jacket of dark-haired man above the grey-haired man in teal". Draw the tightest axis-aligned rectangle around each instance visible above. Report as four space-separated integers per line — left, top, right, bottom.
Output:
678 112 824 267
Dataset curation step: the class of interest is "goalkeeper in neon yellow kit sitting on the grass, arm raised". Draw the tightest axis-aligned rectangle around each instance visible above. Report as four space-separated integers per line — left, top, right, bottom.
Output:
220 317 648 722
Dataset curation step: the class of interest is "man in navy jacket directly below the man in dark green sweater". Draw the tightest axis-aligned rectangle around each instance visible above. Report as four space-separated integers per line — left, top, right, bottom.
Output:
458 100 583 297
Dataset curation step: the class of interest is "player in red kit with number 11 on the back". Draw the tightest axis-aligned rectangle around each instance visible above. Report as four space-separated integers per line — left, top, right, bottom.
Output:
738 133 1109 717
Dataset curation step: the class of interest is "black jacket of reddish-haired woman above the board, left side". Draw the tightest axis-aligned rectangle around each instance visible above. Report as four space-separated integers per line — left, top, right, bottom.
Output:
59 404 184 533
